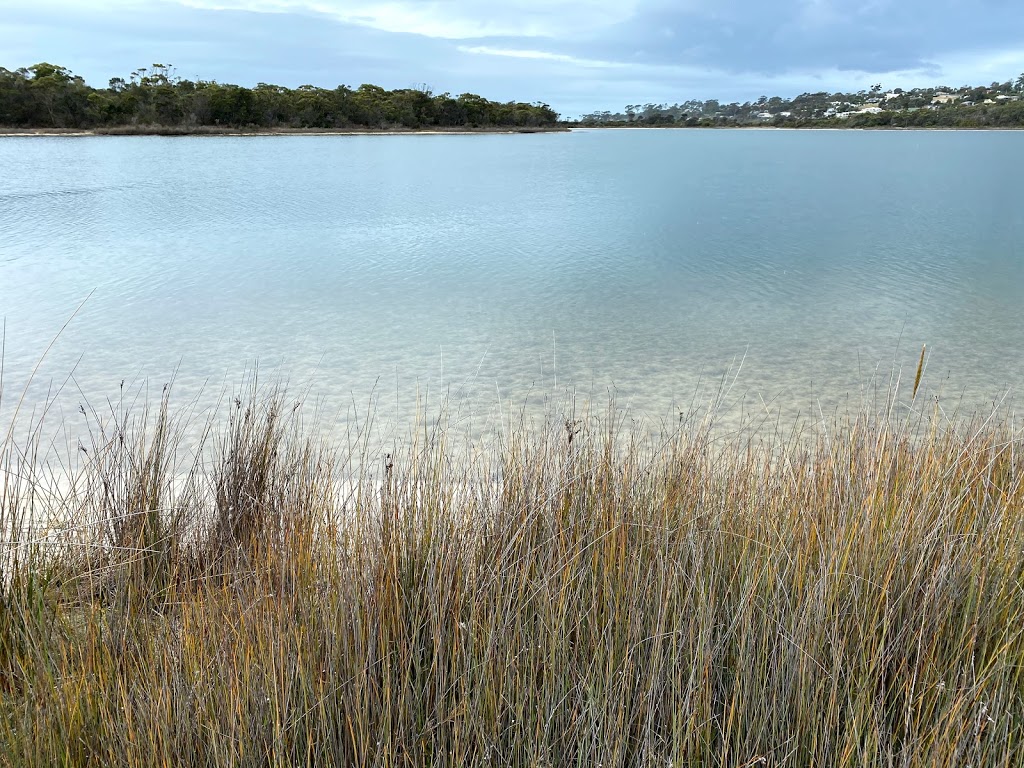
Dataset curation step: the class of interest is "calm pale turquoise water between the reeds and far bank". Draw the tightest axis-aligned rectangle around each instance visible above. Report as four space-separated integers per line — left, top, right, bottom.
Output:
0 131 1024 442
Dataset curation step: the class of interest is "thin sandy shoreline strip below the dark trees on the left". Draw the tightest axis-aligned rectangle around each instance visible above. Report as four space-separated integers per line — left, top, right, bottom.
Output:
0 125 571 137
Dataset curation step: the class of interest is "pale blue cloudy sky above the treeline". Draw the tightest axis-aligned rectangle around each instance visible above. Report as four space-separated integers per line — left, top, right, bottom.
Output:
0 0 1024 116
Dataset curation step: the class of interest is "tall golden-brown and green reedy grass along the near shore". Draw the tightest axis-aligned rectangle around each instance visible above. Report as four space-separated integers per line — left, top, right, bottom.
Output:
0 382 1024 768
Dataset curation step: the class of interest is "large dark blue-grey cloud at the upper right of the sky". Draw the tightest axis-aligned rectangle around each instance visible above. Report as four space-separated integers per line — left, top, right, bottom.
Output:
559 0 1020 76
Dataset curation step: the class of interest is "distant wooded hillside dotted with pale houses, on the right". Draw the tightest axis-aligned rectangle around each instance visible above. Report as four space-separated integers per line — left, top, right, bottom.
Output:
580 74 1024 128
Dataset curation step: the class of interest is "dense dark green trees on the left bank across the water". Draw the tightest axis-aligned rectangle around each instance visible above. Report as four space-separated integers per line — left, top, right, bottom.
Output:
0 63 558 133
